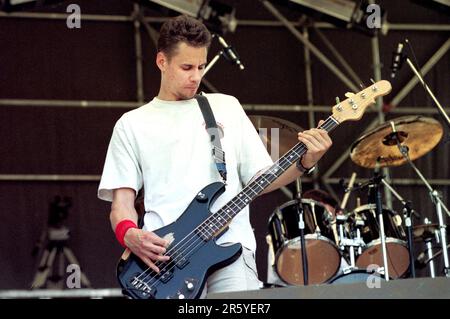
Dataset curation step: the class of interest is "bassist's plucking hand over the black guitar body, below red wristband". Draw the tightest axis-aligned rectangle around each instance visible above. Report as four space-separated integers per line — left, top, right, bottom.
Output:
124 228 170 273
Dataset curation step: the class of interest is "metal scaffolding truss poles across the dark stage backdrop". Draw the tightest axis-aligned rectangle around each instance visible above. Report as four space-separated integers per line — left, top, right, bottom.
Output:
0 1 450 195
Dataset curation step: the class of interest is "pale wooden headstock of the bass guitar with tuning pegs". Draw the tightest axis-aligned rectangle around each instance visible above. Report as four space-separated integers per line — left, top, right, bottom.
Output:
333 80 392 123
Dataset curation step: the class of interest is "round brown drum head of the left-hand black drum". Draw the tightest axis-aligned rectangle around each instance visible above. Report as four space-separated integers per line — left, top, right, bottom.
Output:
275 235 341 285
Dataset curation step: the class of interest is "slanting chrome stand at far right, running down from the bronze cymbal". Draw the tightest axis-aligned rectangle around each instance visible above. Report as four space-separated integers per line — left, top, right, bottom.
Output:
390 121 450 278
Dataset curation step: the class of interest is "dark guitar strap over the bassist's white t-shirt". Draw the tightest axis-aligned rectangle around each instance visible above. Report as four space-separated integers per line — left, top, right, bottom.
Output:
195 94 227 184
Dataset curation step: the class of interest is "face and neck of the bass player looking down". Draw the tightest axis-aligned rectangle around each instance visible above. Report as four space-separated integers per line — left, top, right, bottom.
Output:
156 42 207 101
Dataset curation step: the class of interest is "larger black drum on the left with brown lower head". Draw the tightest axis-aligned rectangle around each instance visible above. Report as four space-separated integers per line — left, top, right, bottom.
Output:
269 199 341 285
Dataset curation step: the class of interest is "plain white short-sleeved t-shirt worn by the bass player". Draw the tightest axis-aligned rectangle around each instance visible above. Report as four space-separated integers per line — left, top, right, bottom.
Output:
98 94 273 251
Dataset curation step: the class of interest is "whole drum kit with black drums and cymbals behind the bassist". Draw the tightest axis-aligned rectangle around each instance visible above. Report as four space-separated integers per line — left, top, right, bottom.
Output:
256 116 448 285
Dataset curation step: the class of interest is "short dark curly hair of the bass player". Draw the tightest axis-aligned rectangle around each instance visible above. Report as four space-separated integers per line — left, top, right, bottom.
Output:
158 15 211 57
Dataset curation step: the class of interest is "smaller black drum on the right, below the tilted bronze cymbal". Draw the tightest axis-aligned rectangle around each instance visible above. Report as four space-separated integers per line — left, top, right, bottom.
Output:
352 204 409 279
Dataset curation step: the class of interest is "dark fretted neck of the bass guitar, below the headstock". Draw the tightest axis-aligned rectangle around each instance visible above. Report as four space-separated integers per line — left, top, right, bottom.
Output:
206 116 339 229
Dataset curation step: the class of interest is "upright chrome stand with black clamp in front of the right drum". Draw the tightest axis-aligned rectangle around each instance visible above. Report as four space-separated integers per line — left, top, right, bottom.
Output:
369 169 389 281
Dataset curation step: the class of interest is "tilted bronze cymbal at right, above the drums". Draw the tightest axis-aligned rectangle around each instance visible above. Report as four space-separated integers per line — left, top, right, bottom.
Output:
350 115 444 168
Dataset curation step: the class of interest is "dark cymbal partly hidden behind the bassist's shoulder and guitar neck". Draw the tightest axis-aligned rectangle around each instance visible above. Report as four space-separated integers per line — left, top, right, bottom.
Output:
249 115 304 161
